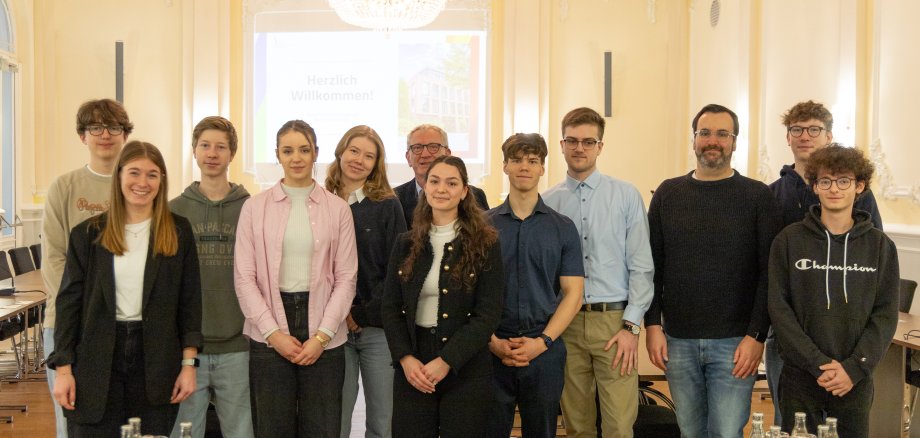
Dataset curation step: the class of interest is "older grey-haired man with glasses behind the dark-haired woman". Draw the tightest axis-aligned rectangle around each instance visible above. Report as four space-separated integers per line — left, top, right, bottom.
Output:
393 124 489 229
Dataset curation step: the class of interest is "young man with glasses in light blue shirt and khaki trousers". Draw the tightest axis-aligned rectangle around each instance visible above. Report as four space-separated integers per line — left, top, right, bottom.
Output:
543 108 654 438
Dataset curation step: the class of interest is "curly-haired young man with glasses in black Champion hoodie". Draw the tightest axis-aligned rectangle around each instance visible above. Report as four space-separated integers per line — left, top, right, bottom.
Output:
769 145 900 437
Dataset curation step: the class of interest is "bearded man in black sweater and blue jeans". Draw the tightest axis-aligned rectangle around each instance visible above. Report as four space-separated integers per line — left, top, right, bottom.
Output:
645 104 781 438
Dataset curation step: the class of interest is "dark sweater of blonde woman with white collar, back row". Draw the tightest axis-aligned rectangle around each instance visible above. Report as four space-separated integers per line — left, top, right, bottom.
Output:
351 197 406 327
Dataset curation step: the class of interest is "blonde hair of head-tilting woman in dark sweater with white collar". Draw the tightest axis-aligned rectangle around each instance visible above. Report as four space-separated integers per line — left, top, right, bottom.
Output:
326 125 396 201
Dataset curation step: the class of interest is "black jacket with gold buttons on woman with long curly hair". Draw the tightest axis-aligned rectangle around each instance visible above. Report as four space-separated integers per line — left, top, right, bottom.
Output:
380 233 505 375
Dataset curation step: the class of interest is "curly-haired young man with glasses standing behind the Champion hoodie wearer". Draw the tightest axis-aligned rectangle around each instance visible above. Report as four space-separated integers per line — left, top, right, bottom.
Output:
764 100 882 426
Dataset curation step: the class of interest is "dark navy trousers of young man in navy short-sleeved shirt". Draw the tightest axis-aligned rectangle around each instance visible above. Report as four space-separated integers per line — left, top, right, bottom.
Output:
486 336 566 438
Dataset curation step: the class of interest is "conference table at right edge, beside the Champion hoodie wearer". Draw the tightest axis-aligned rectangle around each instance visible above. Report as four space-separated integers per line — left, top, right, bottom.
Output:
868 312 920 438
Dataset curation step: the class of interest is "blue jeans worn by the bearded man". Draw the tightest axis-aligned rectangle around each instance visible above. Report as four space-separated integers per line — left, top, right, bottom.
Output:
665 336 756 438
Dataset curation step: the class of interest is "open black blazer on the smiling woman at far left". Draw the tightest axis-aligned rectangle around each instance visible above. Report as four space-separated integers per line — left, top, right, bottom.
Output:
48 214 202 423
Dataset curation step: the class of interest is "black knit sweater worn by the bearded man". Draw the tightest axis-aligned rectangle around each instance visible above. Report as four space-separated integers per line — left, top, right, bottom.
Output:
645 172 781 339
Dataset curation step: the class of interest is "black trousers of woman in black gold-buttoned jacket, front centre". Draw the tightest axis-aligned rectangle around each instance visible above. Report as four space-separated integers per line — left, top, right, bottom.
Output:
393 327 493 438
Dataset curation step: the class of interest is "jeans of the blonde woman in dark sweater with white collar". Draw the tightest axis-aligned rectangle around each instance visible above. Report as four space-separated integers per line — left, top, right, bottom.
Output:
340 327 393 438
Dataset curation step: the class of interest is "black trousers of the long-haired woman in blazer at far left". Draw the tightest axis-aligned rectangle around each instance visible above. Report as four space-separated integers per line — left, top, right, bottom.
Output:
67 321 179 438
